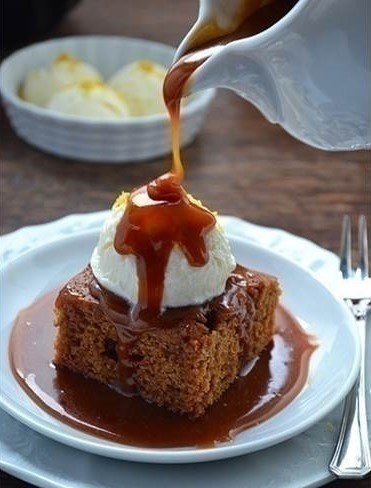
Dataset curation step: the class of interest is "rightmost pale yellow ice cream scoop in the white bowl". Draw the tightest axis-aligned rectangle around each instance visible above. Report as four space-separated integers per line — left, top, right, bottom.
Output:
108 60 166 116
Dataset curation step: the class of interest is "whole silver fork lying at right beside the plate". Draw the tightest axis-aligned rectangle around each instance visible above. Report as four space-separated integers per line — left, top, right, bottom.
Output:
329 215 371 478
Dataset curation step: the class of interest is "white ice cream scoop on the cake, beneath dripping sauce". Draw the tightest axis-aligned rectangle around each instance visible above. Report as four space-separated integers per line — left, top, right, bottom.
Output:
91 193 236 308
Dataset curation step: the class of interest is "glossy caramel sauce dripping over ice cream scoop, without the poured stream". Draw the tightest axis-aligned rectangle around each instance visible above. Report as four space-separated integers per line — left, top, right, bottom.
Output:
114 173 215 314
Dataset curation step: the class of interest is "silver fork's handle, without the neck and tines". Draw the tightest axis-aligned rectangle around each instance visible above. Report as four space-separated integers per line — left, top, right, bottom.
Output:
329 317 371 478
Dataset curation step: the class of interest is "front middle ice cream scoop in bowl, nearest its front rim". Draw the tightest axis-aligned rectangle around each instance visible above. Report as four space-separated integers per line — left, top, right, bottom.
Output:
46 81 129 119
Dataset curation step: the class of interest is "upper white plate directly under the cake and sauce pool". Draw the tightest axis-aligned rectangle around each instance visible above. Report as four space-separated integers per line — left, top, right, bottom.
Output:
0 217 359 463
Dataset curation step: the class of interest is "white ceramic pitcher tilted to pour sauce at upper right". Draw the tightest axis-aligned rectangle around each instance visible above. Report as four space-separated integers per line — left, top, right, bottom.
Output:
176 0 371 150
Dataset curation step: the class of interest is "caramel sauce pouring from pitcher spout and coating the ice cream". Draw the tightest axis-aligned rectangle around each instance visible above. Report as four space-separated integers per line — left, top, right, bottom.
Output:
114 0 295 314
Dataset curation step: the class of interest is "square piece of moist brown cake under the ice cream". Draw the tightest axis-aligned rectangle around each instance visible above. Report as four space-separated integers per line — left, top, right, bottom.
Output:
54 266 280 417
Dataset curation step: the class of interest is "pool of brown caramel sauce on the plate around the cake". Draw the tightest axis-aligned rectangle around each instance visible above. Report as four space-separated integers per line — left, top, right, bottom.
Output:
10 290 315 447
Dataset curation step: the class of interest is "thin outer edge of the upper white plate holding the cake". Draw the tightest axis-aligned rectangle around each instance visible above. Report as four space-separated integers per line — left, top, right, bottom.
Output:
0 228 360 464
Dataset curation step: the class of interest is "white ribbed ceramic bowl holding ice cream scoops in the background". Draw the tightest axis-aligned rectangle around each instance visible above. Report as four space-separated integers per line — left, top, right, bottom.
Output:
0 36 215 163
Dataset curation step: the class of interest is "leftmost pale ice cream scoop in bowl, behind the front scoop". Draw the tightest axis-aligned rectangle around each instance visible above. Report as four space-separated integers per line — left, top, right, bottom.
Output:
20 54 102 107
